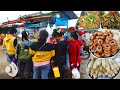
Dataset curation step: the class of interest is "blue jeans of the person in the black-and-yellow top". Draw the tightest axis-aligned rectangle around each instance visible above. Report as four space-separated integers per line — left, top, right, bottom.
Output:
33 63 50 79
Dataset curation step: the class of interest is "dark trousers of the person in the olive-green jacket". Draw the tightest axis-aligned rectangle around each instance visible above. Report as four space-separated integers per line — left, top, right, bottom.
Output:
18 60 33 79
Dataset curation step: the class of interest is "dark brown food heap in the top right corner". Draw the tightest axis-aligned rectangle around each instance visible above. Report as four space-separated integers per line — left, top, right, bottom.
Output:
101 11 120 29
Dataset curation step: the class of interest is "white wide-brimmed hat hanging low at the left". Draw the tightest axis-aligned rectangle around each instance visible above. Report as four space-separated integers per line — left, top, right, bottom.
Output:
5 62 18 77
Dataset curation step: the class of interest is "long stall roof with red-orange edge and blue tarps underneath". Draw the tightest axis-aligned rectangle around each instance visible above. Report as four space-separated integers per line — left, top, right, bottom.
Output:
1 11 78 28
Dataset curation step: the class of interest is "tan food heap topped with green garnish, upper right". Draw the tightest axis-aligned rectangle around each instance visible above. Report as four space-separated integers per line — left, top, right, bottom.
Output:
75 11 101 30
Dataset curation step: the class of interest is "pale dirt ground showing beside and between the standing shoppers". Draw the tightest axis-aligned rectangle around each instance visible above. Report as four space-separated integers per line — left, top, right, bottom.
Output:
0 46 120 79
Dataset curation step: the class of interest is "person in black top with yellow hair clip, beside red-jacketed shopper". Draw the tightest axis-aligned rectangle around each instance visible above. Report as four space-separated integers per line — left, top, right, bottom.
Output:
52 29 67 78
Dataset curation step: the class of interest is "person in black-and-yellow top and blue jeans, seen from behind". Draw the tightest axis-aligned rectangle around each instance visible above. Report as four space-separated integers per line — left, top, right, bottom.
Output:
30 30 55 79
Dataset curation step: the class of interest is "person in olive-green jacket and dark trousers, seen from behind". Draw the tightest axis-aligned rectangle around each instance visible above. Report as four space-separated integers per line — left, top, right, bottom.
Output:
16 31 33 79
